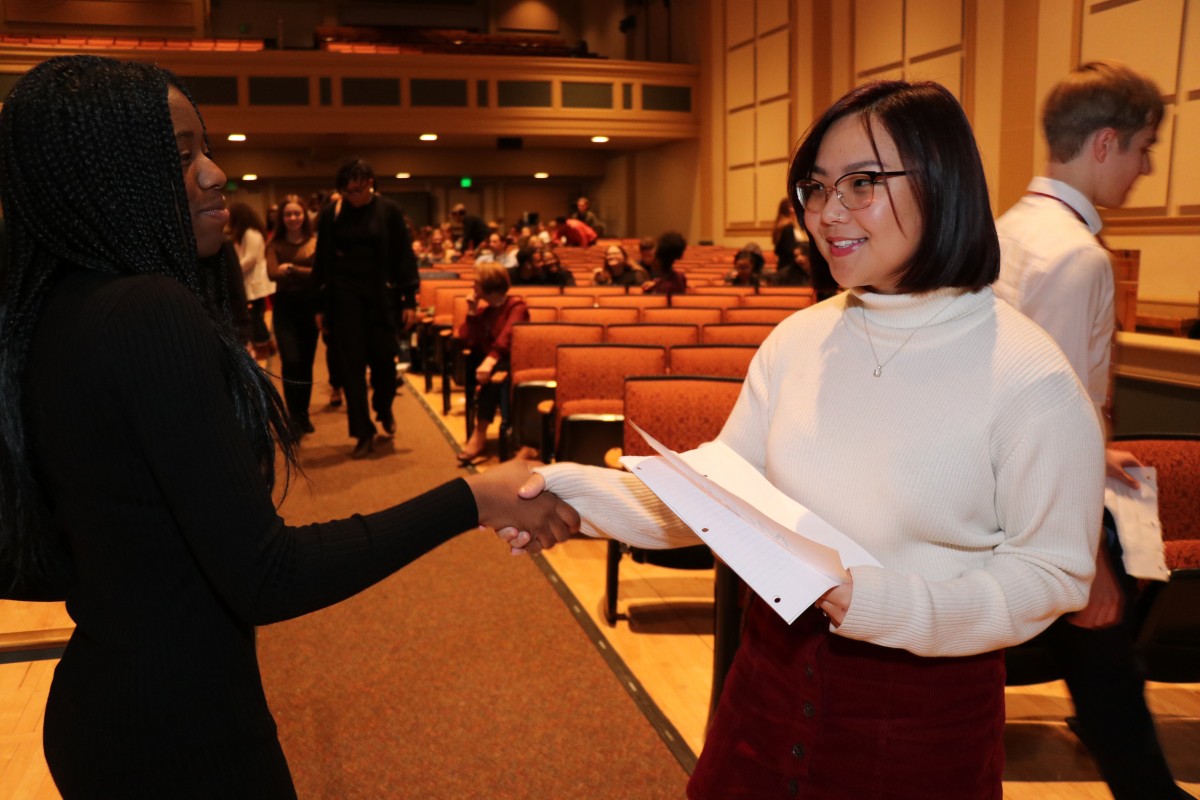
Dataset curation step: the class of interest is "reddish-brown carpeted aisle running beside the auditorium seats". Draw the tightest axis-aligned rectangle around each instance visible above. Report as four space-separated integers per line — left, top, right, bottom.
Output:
258 381 686 800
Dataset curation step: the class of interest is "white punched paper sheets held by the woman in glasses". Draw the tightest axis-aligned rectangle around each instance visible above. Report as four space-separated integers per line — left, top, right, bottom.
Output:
620 422 878 622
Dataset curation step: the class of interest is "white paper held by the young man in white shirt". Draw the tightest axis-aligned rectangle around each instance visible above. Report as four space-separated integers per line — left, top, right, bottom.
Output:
1104 467 1171 581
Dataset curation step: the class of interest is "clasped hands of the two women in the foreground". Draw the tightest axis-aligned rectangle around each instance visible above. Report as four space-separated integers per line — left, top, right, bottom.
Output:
467 459 580 555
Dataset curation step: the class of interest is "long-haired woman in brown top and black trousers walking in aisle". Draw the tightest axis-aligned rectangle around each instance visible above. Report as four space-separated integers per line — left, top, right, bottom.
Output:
266 194 320 439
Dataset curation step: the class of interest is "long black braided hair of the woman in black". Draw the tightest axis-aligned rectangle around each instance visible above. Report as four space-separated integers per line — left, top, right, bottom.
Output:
0 55 296 587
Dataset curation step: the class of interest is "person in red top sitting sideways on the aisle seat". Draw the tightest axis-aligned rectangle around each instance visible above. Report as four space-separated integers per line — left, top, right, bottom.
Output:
456 261 529 464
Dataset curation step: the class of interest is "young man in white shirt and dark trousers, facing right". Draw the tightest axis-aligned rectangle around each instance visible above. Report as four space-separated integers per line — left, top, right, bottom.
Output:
996 61 1190 800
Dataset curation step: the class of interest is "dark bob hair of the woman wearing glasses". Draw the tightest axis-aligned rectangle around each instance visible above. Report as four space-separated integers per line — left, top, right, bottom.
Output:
787 80 1000 293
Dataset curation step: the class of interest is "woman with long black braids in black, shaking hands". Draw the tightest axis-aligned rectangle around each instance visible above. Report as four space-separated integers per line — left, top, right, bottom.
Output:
0 56 577 800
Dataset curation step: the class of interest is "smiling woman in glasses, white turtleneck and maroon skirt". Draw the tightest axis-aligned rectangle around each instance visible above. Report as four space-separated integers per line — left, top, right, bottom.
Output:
509 82 1103 800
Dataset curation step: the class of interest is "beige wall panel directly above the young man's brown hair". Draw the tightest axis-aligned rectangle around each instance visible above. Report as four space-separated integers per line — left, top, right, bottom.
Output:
1080 0 1183 94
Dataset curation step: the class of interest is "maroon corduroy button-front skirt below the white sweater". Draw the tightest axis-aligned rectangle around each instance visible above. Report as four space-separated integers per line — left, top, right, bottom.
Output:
688 597 1004 800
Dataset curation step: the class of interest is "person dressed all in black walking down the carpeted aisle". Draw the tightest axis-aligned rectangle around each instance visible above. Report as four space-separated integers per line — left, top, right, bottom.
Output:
312 160 421 458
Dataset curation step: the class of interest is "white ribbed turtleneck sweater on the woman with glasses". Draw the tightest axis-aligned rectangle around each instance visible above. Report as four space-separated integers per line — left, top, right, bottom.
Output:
539 289 1104 656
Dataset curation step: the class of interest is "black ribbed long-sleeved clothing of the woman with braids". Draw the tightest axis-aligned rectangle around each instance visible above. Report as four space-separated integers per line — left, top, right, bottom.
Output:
28 272 478 800
